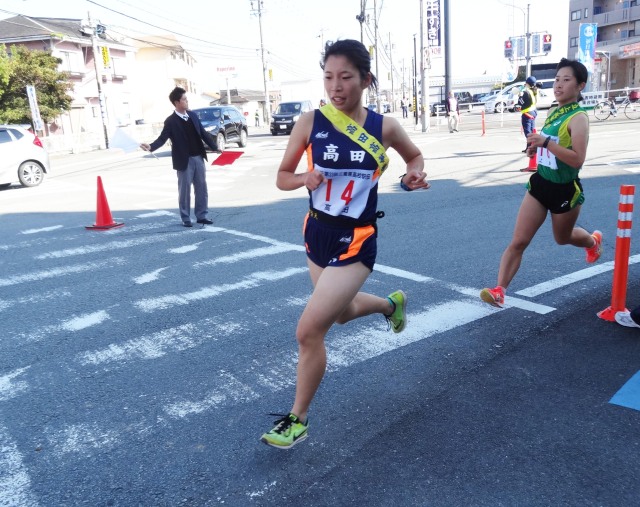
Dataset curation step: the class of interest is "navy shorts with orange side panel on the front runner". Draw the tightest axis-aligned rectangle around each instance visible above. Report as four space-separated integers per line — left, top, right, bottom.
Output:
303 215 378 271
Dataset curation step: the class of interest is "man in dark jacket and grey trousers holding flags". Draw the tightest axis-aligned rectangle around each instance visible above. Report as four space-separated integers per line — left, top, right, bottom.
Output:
140 86 218 227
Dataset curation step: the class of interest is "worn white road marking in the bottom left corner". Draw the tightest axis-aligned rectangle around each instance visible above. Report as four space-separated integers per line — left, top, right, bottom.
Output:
0 423 38 507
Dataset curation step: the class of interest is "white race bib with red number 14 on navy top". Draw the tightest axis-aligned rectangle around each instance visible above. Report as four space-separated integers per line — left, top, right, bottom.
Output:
311 164 377 219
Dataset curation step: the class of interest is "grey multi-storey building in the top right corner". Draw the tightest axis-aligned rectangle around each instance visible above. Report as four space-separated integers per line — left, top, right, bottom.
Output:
567 0 640 91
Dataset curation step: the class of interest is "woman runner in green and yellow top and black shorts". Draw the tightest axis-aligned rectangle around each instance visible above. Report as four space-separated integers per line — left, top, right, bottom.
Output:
480 58 602 307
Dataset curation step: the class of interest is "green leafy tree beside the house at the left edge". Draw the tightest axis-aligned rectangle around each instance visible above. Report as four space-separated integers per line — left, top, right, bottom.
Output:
0 45 73 127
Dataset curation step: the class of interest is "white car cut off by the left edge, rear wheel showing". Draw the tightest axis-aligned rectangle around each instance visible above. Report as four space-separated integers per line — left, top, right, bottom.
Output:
0 125 49 188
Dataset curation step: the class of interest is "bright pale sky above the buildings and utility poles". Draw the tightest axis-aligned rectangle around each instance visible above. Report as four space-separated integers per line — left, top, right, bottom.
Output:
0 0 572 91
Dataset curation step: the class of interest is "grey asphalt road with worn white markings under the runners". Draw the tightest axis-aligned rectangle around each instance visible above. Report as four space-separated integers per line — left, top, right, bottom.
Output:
0 115 640 507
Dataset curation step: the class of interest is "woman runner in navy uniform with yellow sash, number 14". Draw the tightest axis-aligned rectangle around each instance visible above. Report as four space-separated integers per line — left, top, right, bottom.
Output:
260 39 429 449
